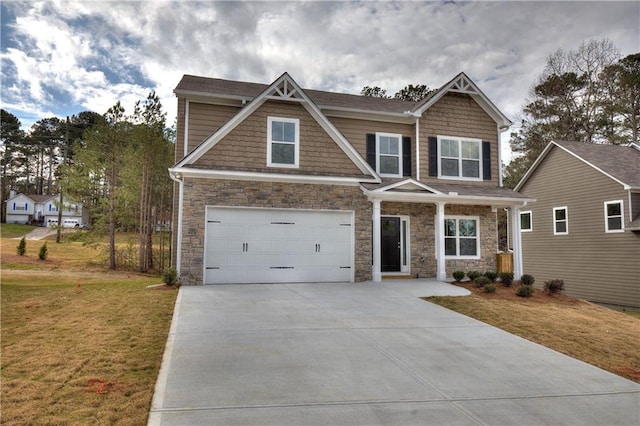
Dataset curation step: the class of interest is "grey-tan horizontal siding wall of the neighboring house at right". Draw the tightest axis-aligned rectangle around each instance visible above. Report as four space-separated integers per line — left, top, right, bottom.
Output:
520 148 640 306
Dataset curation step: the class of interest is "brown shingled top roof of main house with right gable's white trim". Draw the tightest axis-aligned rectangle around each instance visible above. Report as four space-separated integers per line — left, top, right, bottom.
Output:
174 72 512 127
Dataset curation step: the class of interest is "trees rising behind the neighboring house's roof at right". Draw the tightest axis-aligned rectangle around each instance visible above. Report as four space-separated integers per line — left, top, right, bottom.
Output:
504 39 640 188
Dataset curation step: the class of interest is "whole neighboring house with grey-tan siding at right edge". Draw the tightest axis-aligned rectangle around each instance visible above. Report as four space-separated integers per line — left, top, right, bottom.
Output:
515 142 640 307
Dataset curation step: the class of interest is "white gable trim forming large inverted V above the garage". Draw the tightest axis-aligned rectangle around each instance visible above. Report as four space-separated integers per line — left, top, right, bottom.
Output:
174 73 378 180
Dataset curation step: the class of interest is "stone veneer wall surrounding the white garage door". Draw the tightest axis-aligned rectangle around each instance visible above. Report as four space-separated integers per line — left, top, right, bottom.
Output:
180 179 372 285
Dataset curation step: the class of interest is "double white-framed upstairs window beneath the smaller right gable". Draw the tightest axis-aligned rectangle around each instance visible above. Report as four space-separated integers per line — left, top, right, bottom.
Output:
438 136 482 180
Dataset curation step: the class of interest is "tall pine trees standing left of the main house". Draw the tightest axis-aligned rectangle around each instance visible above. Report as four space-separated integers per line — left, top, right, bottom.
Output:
0 93 175 272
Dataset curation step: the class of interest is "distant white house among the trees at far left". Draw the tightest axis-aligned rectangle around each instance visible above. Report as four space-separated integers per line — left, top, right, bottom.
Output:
7 191 86 228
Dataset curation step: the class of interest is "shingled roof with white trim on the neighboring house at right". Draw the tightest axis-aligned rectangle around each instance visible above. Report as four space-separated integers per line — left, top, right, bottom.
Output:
515 141 640 191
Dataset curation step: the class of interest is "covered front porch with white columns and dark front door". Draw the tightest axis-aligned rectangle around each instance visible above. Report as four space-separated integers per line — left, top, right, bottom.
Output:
364 179 528 282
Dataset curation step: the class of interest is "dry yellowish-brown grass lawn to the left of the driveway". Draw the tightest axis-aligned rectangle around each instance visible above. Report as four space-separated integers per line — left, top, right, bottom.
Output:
0 270 177 425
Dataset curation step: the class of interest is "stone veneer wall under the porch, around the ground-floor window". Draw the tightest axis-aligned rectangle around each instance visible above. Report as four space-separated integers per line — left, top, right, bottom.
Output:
381 202 498 278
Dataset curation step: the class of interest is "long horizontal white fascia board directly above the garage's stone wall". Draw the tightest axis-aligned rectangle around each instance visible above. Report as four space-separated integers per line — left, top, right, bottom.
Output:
169 167 379 186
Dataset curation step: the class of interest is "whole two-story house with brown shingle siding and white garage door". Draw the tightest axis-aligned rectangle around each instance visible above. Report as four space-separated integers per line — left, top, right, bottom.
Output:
169 73 529 285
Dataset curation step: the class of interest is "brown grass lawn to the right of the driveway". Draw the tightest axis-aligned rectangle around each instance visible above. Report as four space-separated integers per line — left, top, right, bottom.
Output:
426 283 640 382
